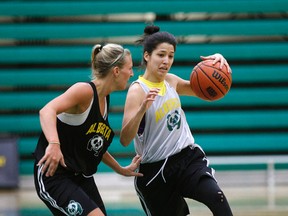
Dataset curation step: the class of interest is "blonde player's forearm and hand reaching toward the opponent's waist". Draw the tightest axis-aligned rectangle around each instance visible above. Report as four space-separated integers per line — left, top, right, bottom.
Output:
102 151 143 177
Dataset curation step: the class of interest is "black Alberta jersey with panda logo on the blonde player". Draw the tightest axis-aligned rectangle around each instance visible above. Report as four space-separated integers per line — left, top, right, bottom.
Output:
35 82 114 176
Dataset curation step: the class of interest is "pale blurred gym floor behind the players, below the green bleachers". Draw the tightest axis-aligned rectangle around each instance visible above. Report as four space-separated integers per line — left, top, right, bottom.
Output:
0 170 288 216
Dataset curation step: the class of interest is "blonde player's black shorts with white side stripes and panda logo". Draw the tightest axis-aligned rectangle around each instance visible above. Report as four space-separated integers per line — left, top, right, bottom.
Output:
34 163 106 215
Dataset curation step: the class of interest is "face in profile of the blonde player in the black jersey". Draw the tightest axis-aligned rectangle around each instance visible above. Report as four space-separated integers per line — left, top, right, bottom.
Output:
116 55 134 90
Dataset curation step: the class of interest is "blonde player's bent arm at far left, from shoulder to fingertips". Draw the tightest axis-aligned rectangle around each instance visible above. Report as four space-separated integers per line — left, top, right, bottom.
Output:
38 83 93 177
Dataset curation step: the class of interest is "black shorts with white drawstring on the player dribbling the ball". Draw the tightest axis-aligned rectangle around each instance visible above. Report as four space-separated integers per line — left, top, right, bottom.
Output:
135 147 216 216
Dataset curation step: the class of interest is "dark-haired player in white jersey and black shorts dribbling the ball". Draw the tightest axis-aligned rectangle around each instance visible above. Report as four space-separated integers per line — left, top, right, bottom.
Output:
120 26 232 216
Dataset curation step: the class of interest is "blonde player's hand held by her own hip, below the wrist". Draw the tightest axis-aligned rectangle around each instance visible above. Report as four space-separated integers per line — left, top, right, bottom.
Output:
37 144 67 177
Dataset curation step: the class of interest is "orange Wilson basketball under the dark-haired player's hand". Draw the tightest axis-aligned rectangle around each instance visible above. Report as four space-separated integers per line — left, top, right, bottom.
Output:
190 60 232 101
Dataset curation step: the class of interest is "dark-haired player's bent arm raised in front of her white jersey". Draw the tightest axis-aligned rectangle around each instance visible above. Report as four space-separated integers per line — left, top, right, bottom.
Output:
120 83 159 146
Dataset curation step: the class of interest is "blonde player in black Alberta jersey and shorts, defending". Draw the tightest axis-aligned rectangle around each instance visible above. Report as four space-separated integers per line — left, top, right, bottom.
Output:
34 44 141 216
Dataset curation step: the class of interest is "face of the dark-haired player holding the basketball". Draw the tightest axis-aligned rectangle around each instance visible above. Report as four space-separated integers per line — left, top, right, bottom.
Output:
144 43 175 81
